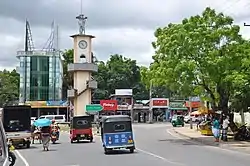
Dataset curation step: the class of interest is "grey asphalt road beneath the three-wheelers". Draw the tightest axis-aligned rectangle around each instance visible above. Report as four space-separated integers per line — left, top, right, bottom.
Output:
16 124 250 166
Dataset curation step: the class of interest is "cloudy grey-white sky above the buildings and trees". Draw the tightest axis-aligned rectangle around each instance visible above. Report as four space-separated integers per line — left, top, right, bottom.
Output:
0 0 250 70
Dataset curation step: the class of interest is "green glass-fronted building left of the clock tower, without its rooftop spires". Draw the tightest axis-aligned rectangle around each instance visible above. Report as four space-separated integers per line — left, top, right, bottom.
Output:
17 51 63 103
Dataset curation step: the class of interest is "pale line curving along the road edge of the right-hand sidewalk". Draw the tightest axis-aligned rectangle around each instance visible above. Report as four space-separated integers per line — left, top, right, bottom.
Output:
167 130 250 157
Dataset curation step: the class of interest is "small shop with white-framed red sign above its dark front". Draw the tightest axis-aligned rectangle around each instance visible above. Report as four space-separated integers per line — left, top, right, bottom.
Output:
150 98 169 121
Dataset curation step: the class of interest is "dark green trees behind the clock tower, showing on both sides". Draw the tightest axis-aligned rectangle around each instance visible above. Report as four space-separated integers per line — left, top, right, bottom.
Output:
63 49 148 99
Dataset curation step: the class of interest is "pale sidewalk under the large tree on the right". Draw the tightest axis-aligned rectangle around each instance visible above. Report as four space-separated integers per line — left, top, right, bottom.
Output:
173 125 250 153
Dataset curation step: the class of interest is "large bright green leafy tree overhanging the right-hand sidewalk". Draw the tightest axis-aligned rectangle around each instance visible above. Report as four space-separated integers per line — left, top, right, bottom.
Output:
149 8 249 113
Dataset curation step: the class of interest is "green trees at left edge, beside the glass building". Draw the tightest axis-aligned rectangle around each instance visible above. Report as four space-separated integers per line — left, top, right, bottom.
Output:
0 70 19 107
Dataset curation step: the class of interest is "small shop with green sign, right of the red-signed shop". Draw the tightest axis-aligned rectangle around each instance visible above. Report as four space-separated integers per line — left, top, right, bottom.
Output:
166 101 188 120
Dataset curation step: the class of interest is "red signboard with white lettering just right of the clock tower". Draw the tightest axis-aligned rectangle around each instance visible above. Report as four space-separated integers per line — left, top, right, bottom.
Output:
99 100 118 116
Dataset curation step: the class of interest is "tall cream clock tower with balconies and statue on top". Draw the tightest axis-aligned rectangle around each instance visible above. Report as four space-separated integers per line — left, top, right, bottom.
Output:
68 14 98 116
